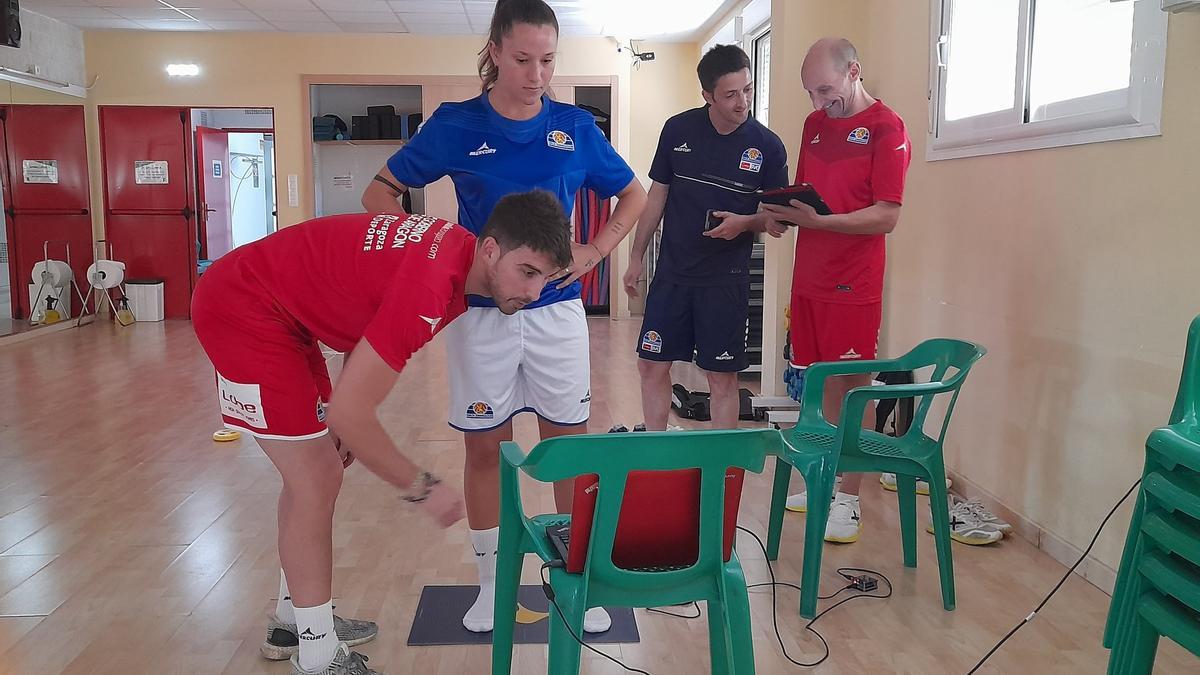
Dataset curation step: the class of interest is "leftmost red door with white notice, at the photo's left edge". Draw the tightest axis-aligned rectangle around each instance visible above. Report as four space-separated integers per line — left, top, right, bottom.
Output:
4 106 92 318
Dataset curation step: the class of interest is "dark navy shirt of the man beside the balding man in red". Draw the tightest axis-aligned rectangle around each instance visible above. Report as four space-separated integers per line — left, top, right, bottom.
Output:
650 106 787 286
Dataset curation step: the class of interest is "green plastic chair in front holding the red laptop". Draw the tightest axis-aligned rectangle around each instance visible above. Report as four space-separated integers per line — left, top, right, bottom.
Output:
492 429 782 675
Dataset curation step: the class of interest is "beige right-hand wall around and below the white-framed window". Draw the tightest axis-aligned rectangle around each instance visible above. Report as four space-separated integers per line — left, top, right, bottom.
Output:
772 0 1200 567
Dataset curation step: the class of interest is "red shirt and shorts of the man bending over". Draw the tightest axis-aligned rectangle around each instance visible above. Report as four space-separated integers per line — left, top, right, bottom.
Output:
192 214 475 438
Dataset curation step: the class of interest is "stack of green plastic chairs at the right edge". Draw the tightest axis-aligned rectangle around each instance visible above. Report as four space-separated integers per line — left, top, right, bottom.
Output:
1104 317 1200 675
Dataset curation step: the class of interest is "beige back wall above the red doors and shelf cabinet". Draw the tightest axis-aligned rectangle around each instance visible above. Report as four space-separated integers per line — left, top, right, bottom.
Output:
84 31 652 225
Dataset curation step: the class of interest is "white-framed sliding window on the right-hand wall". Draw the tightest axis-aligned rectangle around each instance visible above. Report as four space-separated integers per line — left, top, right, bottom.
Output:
929 0 1166 160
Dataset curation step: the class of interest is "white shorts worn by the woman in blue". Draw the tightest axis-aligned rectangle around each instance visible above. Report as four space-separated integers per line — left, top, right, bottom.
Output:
443 299 592 431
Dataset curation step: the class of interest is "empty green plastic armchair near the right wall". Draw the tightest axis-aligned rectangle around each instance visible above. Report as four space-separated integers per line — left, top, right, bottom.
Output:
767 339 988 619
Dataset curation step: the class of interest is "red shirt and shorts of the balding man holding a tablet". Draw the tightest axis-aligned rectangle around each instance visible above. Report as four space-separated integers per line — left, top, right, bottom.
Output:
792 101 912 305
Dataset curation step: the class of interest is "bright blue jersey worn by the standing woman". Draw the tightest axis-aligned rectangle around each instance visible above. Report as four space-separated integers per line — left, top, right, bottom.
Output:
388 95 634 307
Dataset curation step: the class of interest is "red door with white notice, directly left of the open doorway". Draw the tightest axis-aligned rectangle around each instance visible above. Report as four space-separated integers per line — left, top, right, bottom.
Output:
100 106 197 318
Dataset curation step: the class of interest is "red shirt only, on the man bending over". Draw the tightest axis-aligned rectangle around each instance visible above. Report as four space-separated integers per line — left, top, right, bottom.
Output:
235 215 475 372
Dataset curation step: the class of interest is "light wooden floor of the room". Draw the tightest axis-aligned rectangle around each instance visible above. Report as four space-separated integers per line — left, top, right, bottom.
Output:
0 319 1196 675
